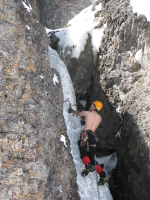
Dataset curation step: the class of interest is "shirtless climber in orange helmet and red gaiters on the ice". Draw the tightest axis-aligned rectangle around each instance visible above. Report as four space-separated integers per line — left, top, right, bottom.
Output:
68 101 108 185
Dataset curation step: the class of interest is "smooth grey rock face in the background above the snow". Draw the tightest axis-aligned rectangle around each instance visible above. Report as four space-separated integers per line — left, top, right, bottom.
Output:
37 0 94 29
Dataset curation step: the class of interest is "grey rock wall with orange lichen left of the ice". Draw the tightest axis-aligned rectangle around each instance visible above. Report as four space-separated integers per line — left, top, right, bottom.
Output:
0 0 79 200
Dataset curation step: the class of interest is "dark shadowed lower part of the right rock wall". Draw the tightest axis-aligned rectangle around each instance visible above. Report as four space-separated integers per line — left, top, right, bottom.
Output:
110 112 149 200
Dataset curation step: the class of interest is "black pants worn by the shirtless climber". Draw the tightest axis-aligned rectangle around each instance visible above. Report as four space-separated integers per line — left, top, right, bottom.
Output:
78 130 97 165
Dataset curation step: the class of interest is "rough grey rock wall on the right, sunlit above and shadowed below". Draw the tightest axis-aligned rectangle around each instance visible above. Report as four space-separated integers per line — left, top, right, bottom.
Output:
99 0 150 200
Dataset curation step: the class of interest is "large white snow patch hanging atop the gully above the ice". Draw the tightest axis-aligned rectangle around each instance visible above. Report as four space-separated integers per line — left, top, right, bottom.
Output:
46 4 106 59
